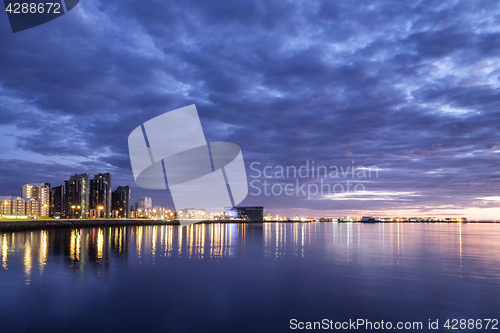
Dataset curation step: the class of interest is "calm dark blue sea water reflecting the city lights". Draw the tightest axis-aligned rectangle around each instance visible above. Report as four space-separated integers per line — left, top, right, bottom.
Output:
0 223 500 332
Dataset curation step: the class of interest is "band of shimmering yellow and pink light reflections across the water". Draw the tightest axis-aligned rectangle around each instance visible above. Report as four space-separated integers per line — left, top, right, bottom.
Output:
0 223 500 284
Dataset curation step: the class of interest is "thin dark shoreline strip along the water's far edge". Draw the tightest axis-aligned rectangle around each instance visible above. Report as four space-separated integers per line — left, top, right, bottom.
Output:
0 219 498 232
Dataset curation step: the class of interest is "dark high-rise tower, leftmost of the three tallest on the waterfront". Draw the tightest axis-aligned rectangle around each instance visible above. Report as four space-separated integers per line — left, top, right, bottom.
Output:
64 173 90 218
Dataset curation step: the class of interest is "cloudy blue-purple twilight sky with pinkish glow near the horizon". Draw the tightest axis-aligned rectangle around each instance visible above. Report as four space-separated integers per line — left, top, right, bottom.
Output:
0 0 500 219
